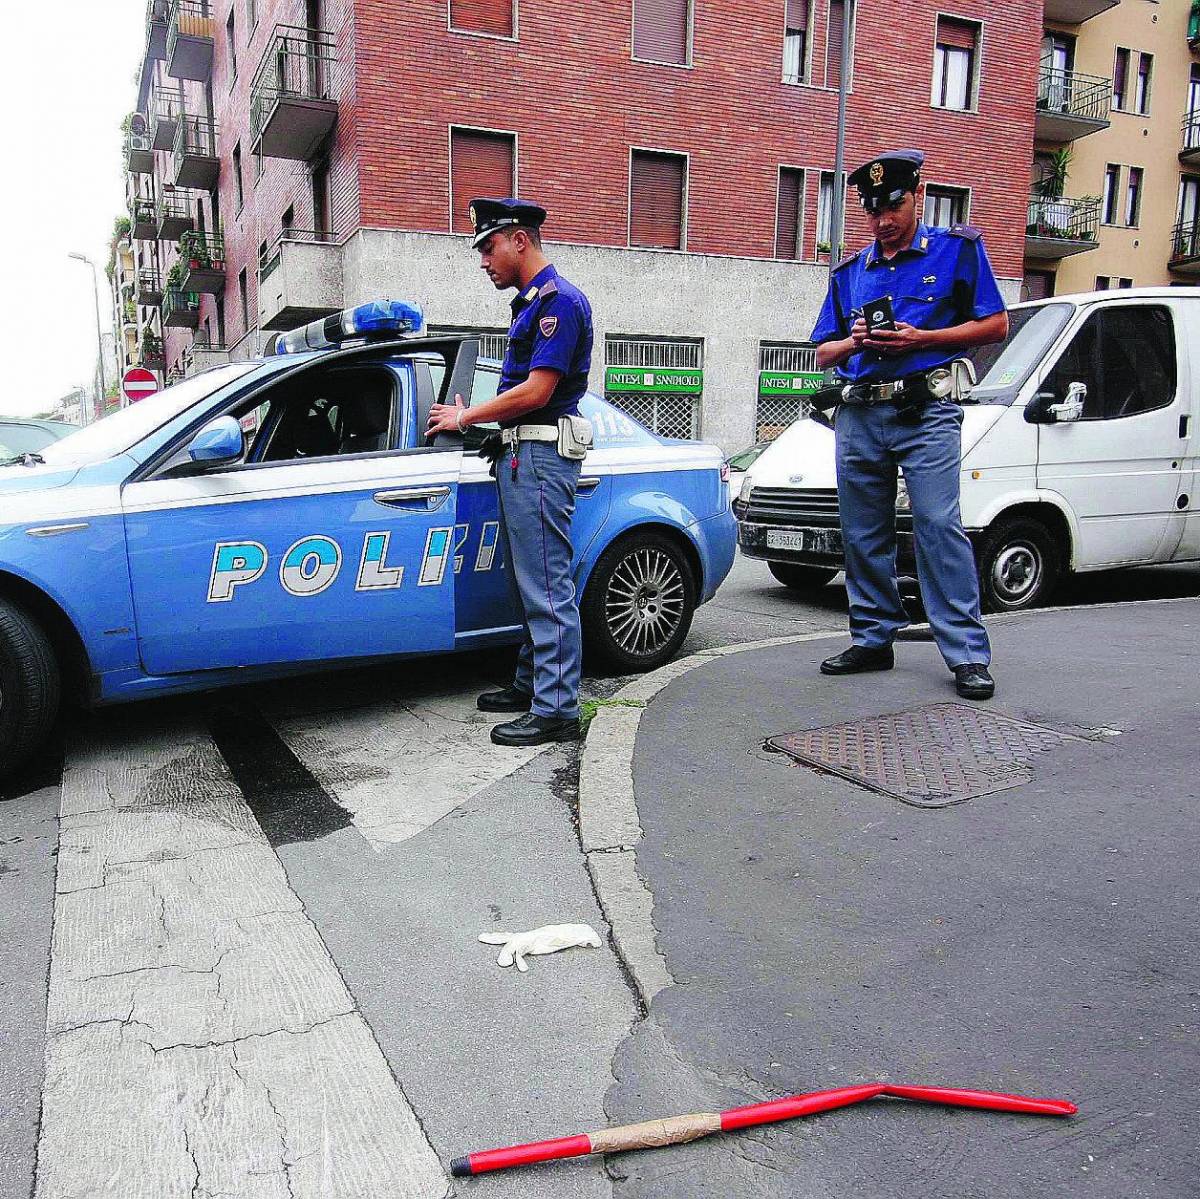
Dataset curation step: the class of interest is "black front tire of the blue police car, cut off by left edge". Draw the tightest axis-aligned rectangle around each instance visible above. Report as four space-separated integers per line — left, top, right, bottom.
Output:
0 599 62 774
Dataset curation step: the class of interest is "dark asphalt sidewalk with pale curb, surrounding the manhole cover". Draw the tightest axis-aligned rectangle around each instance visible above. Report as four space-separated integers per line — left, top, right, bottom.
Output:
581 600 1200 1199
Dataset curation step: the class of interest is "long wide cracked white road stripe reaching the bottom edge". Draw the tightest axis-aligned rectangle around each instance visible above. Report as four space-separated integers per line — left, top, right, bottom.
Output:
36 726 446 1199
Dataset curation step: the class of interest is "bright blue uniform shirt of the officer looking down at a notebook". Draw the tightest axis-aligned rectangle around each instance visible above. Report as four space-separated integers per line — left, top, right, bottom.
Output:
811 224 1004 383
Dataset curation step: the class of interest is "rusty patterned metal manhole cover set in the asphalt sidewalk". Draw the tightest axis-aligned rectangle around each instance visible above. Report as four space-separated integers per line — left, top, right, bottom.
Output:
767 703 1085 808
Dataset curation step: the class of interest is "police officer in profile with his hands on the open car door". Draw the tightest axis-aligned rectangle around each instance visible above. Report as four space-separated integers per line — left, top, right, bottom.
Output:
428 198 592 745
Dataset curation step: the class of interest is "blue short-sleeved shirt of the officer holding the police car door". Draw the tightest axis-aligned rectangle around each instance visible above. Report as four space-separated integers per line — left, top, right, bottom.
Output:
499 266 592 427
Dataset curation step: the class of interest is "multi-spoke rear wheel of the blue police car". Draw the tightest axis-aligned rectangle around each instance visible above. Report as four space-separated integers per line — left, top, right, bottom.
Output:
581 532 696 673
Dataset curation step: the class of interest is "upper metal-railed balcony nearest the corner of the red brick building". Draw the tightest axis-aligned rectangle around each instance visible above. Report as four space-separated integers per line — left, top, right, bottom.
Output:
250 25 337 162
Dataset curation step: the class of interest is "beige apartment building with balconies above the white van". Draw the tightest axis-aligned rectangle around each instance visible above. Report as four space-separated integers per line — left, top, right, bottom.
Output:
1024 0 1200 299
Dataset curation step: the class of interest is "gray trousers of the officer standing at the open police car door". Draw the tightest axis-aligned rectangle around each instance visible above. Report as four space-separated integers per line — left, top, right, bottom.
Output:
496 442 583 720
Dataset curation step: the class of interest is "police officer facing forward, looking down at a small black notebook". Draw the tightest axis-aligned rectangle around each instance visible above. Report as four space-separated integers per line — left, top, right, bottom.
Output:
812 150 1008 700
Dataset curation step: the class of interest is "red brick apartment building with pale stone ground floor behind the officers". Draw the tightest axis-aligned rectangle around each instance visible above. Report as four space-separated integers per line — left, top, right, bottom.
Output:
119 0 1043 449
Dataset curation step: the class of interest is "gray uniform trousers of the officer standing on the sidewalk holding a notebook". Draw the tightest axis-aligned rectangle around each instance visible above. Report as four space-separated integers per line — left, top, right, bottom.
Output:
834 400 991 667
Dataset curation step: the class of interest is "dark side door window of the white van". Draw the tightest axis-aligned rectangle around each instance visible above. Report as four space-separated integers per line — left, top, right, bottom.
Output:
1043 305 1176 420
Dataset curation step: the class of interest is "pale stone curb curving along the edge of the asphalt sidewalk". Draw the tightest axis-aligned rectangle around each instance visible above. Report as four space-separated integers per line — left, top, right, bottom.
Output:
580 595 1200 1009
